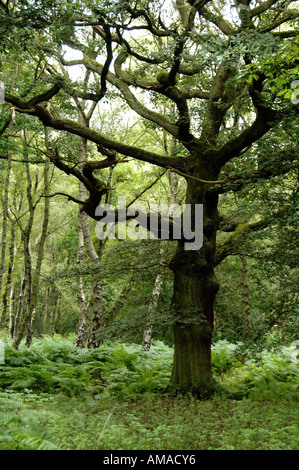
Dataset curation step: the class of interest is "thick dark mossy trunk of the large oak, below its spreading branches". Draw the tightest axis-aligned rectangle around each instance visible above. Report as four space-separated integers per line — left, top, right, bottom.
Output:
169 174 219 398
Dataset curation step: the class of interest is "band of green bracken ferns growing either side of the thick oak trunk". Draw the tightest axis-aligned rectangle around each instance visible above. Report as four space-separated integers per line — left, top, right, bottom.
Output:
0 335 298 400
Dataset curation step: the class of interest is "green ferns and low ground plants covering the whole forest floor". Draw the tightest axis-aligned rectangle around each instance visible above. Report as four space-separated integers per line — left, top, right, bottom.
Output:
0 336 299 450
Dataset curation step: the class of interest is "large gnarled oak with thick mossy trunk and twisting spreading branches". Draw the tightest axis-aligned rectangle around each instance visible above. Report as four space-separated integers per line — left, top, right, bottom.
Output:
0 0 298 397
